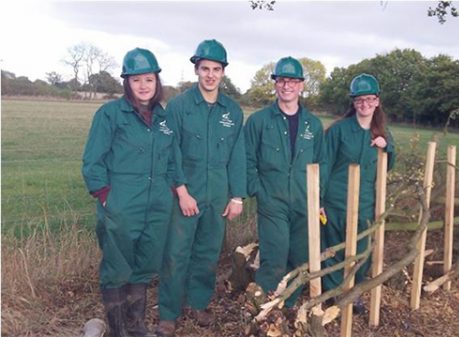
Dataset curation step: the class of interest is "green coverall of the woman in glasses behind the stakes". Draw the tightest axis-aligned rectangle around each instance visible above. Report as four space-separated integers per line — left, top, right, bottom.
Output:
321 115 395 290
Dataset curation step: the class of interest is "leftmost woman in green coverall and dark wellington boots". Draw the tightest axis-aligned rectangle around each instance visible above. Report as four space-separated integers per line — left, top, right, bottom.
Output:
82 48 183 337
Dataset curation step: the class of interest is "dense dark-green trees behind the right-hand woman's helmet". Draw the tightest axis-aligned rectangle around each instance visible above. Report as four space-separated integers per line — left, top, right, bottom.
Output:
319 49 459 126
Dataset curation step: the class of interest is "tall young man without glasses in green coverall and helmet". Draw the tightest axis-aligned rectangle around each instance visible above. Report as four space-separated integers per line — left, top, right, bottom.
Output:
156 40 246 337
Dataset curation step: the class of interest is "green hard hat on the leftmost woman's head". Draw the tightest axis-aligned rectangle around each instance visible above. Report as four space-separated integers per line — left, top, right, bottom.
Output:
121 48 161 78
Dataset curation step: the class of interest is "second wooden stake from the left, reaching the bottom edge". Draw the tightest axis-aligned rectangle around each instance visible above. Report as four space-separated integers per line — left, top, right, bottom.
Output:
341 164 360 337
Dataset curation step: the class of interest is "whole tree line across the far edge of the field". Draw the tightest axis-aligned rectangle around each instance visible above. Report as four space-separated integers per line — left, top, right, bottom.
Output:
1 49 459 127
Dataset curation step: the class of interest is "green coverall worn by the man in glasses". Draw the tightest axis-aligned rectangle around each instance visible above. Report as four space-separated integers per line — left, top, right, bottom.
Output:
245 102 324 306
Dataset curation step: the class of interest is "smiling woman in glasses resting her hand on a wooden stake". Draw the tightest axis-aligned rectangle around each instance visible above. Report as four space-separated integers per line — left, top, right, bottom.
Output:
322 74 395 311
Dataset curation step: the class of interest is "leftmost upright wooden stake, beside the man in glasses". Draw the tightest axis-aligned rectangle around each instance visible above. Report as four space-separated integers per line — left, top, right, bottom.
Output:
307 164 322 308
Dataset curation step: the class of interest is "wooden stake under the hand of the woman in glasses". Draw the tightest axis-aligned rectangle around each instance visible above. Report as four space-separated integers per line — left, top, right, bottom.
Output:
370 149 387 326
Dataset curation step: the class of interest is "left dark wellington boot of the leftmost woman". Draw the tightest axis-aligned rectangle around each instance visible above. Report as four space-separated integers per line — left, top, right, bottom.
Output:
102 288 130 337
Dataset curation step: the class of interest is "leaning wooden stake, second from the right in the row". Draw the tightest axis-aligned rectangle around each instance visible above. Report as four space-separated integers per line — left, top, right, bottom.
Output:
410 142 437 310
